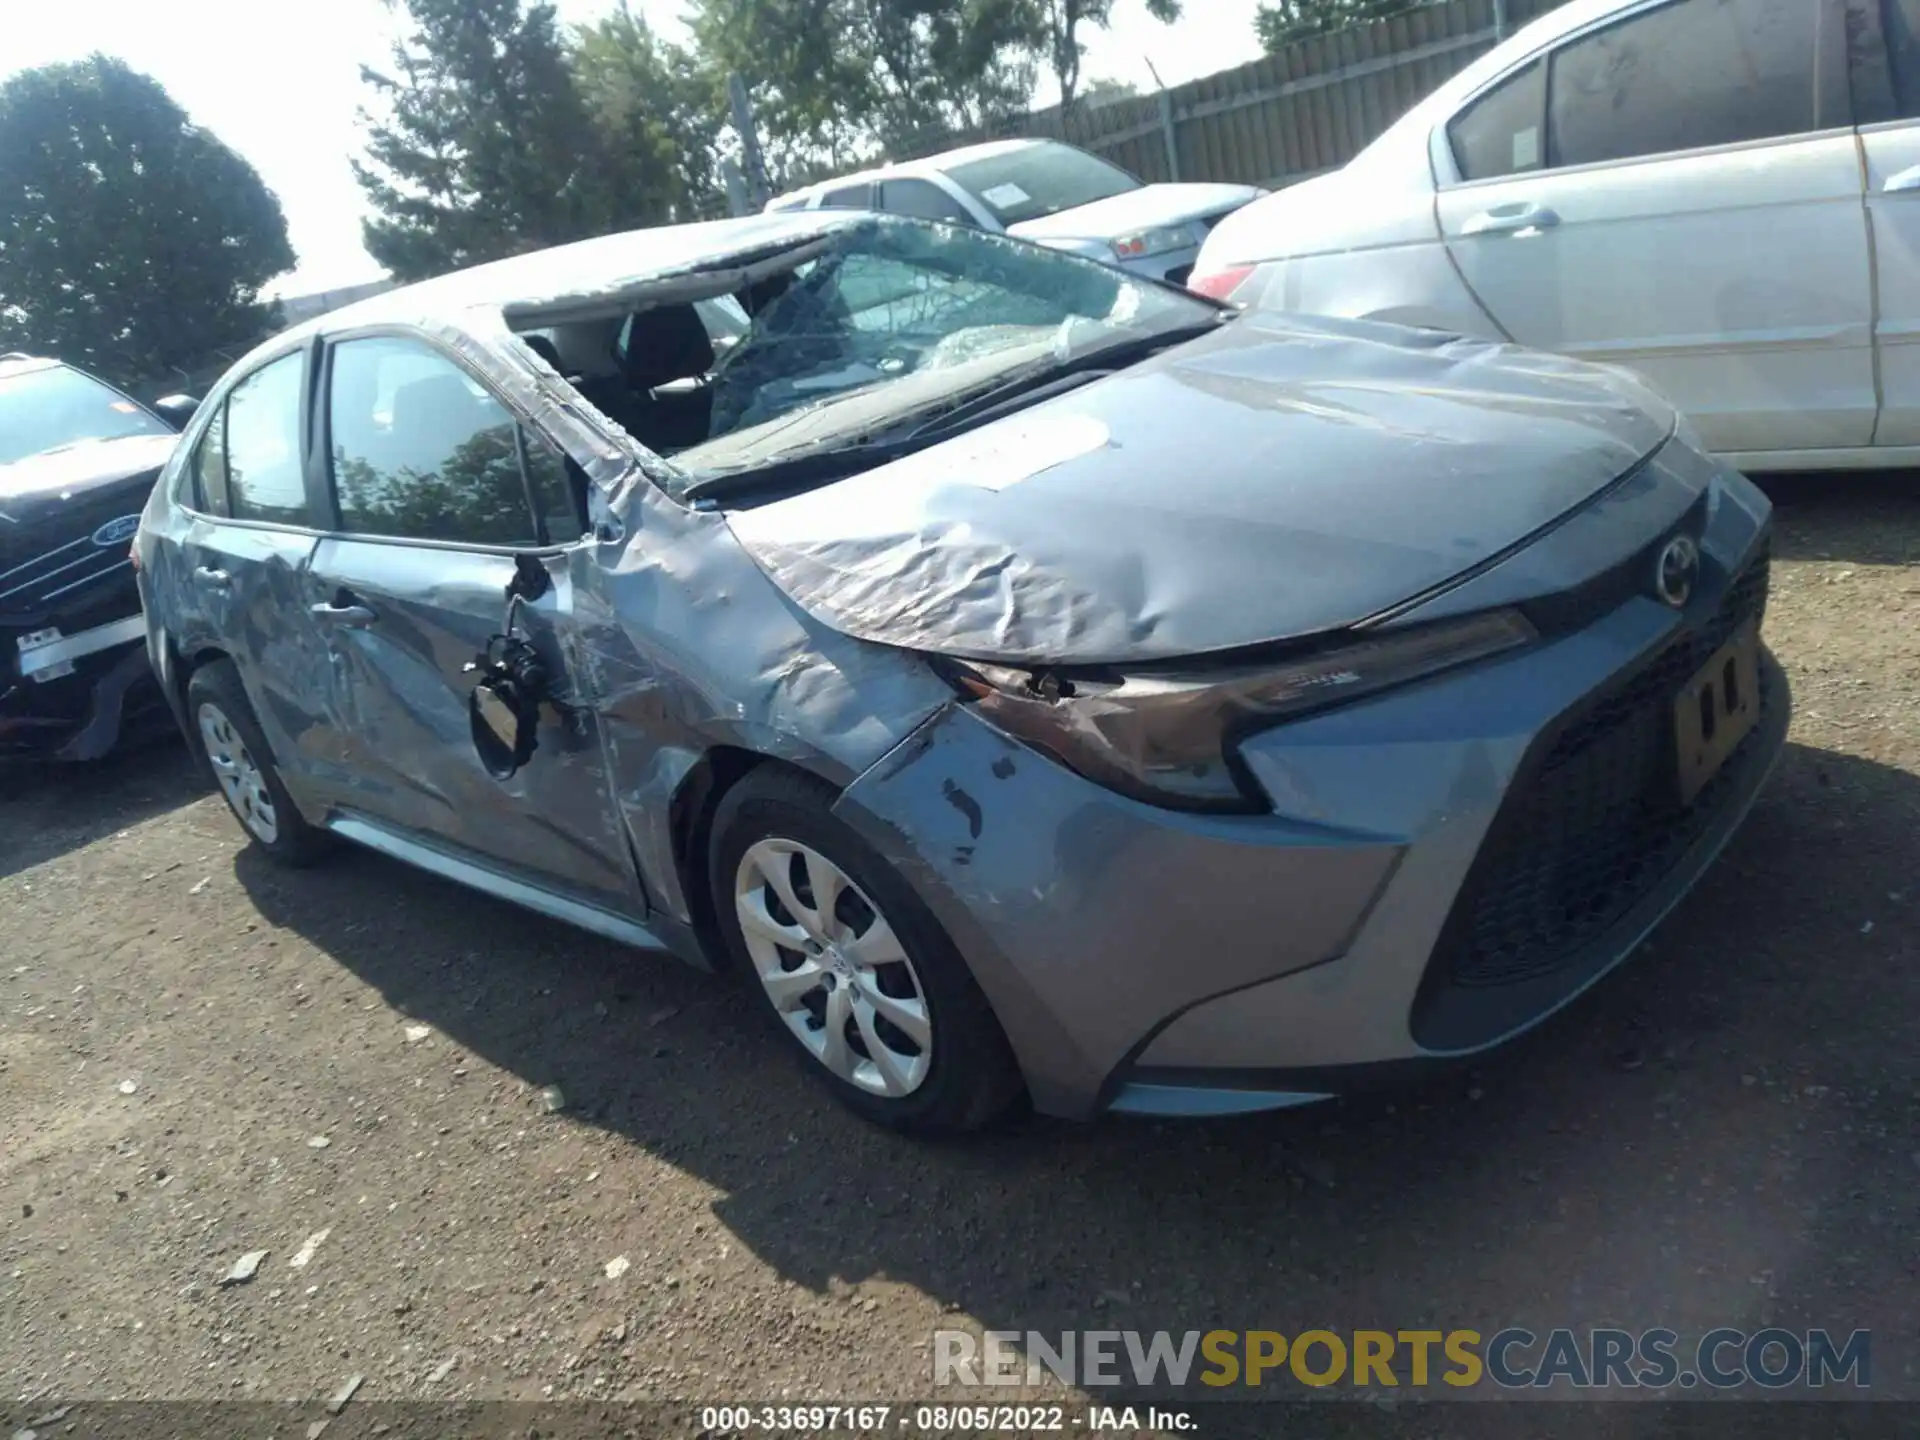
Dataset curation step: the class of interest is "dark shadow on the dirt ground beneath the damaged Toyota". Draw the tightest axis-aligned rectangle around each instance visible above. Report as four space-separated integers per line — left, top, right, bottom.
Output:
236 745 1920 1413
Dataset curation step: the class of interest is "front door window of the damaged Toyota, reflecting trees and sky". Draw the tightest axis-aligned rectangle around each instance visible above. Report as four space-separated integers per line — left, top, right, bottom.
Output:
326 336 540 545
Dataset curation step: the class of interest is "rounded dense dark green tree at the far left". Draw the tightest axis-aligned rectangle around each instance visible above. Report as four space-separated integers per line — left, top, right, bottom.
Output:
0 56 294 382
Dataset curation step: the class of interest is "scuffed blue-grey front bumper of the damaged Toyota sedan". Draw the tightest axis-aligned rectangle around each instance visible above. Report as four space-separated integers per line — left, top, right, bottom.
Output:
839 480 1789 1117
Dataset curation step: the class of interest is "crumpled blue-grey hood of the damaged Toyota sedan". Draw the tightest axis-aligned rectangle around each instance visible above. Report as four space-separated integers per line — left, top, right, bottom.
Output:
728 315 1674 664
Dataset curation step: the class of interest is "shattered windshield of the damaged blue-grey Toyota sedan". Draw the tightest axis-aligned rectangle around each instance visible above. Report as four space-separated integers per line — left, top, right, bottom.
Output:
674 217 1219 495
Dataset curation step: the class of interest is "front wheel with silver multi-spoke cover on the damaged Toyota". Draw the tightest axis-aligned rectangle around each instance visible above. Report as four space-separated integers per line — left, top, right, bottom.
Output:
710 770 1020 1133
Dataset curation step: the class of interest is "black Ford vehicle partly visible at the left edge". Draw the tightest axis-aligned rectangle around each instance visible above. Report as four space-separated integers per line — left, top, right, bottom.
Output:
0 355 194 760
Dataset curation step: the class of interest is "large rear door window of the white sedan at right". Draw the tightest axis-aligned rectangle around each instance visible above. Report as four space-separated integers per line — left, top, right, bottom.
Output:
1548 0 1824 165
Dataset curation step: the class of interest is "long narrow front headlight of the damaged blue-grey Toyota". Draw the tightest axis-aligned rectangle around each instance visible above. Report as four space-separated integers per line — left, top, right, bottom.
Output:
937 611 1534 810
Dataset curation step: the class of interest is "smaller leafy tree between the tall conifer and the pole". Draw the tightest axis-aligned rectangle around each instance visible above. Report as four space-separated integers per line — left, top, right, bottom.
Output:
572 0 726 227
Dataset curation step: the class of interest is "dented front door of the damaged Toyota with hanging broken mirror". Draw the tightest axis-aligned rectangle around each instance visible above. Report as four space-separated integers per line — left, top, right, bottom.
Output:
309 332 645 916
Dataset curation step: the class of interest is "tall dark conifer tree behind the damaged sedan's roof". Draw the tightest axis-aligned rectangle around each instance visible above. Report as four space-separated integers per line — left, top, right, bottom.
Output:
353 0 612 280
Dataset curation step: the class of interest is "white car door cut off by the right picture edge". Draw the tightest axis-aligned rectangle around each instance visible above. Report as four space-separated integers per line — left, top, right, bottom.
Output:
1849 0 1920 445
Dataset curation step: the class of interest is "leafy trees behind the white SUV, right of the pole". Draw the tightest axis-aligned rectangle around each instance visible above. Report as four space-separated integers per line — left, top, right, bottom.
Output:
689 0 1035 184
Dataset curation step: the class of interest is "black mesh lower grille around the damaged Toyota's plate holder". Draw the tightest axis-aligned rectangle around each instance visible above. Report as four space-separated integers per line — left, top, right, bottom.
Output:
1438 551 1776 985
